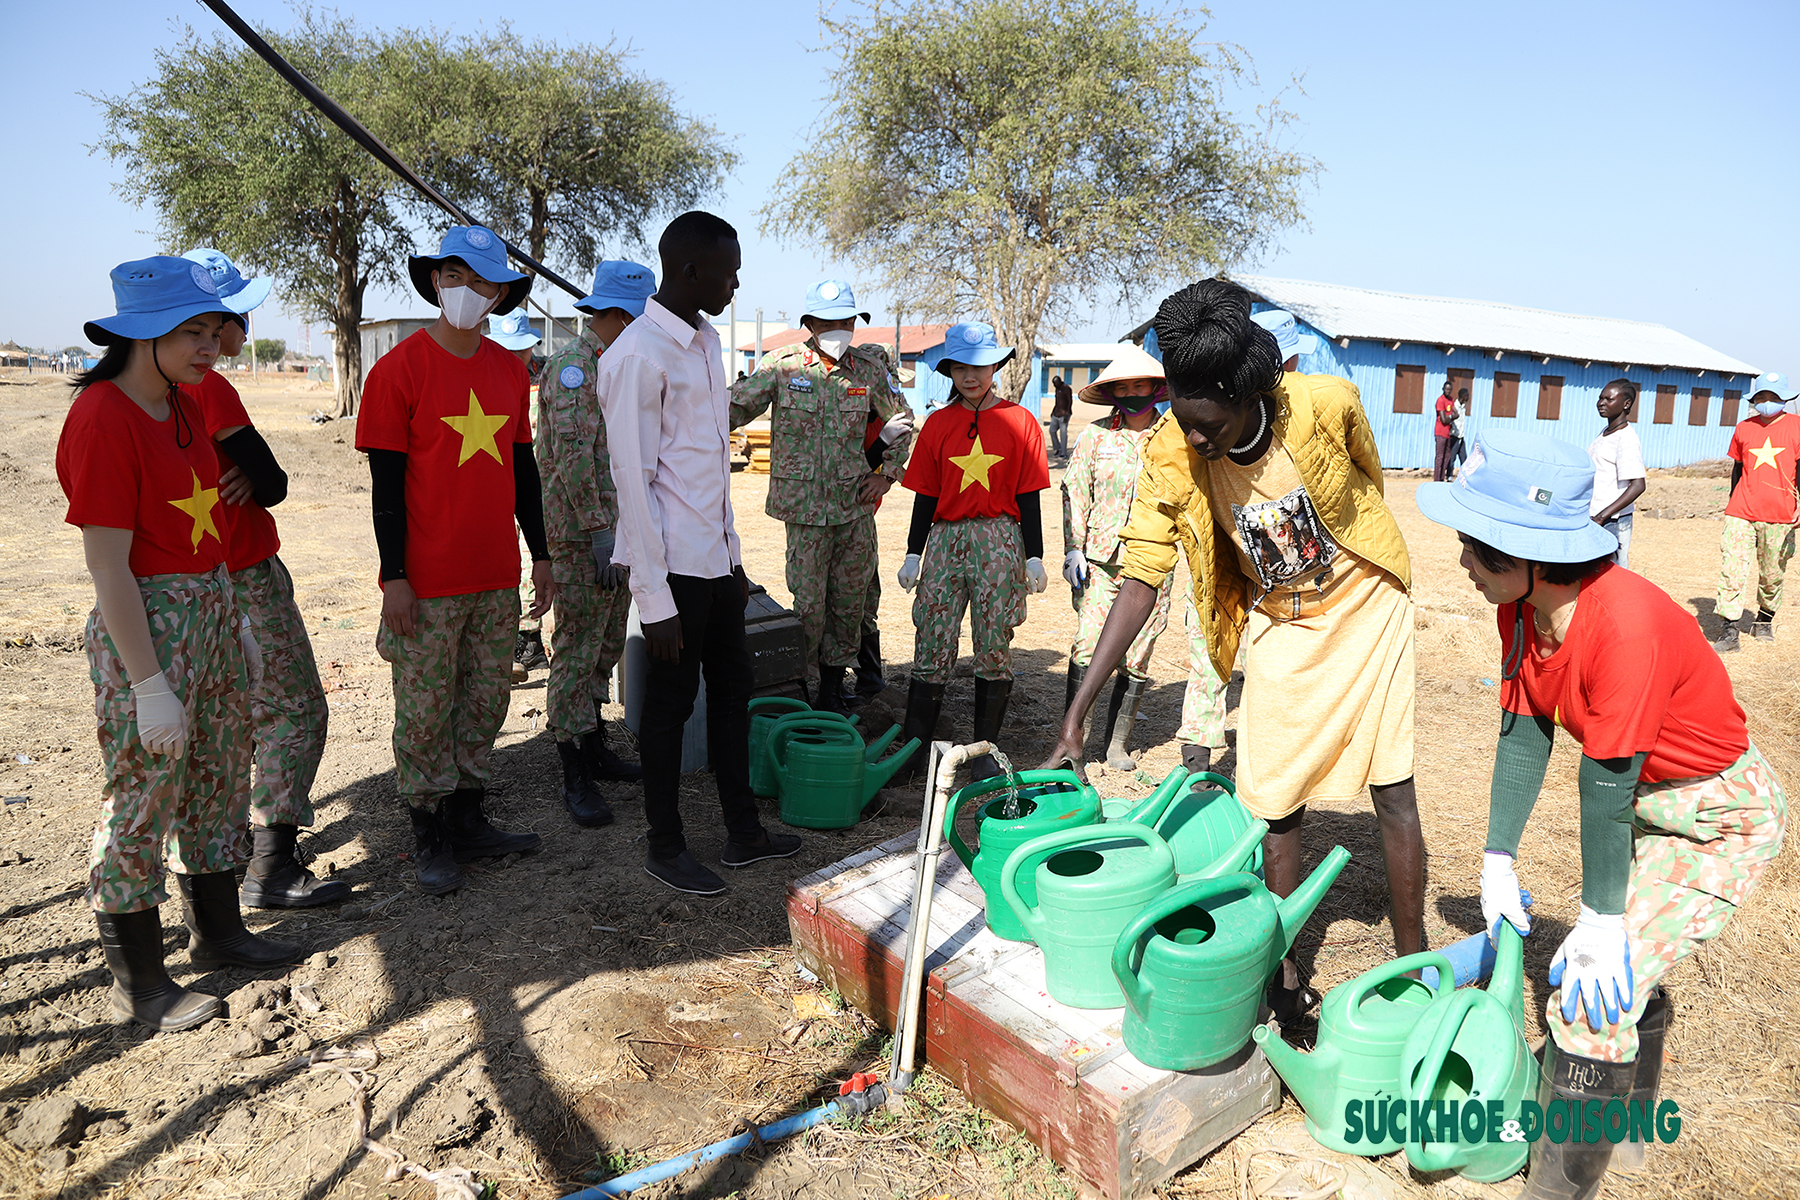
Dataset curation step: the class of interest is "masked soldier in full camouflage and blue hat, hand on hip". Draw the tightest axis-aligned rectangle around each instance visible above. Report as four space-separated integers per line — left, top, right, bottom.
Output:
731 279 913 712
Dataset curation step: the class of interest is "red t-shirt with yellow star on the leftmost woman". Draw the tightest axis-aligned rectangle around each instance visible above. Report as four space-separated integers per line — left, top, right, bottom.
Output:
56 381 225 576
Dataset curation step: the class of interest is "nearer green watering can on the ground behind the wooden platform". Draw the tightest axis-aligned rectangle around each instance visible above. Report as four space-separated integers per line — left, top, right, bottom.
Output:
765 712 918 829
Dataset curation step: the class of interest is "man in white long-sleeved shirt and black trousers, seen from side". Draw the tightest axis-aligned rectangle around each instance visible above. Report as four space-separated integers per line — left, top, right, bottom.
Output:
596 212 801 896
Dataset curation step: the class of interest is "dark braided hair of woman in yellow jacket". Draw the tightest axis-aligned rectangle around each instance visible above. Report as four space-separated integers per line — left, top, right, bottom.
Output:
1156 279 1282 408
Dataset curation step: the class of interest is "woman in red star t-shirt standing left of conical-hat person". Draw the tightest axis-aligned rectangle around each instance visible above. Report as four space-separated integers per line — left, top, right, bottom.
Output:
900 320 1049 779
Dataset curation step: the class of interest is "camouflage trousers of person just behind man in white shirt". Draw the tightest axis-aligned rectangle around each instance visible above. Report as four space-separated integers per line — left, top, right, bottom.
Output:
544 542 632 741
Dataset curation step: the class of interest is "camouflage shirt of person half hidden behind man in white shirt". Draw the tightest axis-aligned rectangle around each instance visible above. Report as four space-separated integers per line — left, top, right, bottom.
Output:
536 331 619 542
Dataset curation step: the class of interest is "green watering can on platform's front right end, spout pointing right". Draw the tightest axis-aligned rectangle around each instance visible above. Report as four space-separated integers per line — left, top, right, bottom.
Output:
1112 845 1350 1070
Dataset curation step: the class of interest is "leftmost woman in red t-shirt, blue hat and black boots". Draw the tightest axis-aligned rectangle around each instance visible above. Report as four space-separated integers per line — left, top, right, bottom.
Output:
56 257 302 1029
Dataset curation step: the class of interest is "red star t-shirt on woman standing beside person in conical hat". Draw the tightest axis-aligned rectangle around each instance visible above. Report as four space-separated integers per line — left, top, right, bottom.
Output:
900 399 1049 520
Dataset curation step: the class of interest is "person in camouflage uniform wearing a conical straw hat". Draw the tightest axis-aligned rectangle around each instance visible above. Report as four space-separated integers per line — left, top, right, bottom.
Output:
1062 345 1174 770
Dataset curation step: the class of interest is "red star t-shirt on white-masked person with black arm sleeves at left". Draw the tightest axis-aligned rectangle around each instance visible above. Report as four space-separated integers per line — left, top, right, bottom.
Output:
356 329 531 597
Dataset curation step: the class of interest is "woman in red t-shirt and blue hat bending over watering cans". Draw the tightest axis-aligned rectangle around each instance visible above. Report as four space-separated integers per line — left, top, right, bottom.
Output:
1418 430 1787 1198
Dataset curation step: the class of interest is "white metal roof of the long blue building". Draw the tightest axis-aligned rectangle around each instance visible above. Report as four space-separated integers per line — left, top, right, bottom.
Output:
1235 275 1757 376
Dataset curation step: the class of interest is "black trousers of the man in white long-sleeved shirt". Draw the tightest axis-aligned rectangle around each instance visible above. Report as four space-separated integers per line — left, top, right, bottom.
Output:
637 574 763 858
